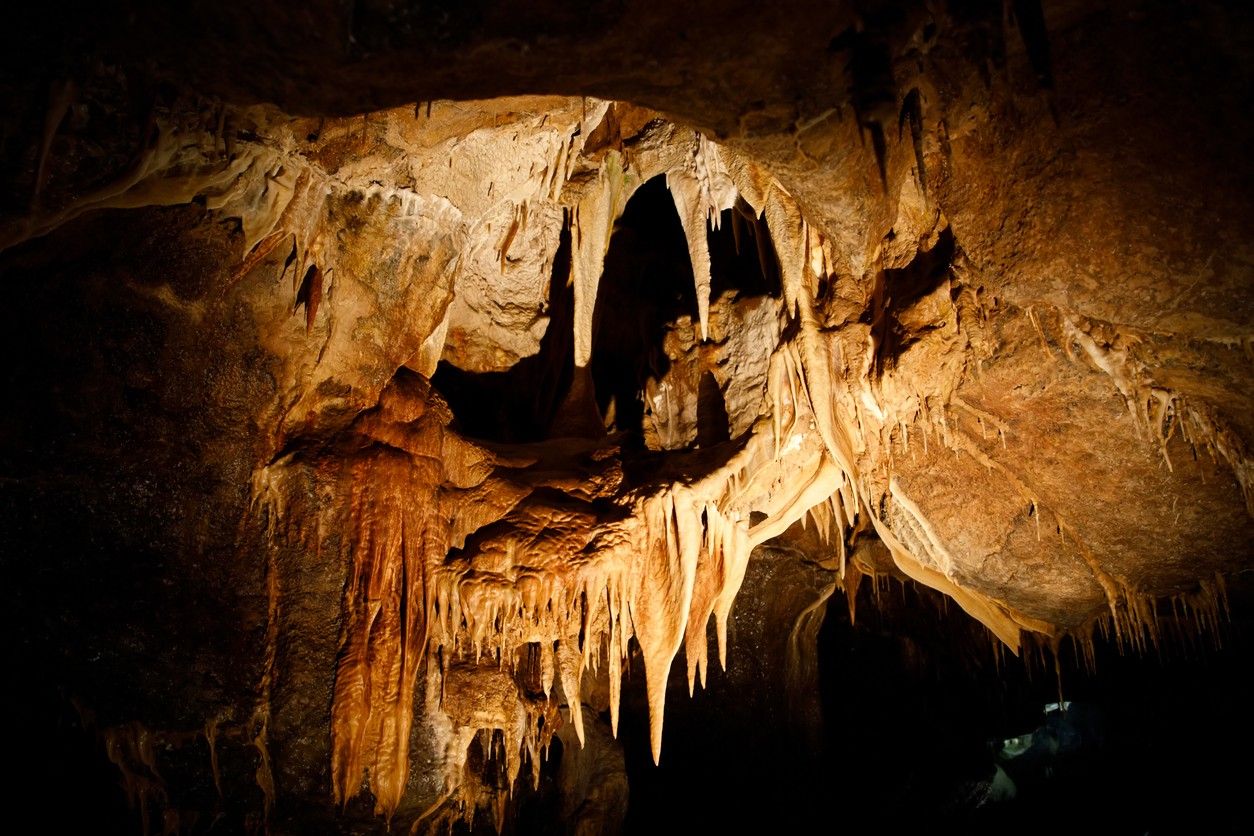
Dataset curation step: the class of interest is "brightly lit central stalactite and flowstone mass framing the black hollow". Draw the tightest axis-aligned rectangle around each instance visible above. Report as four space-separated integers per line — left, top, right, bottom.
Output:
262 132 1210 815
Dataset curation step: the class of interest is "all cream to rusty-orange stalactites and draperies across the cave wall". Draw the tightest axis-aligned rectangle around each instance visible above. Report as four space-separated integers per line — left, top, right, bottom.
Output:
7 81 1254 816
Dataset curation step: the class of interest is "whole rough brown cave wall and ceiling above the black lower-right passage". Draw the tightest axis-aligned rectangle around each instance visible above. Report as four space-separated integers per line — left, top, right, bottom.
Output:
0 3 1254 830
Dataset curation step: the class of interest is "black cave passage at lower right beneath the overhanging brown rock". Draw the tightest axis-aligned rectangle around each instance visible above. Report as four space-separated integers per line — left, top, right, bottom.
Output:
818 578 1254 833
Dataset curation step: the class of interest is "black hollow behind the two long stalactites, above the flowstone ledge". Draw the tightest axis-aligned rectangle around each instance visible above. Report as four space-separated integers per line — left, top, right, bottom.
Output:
431 175 781 452
